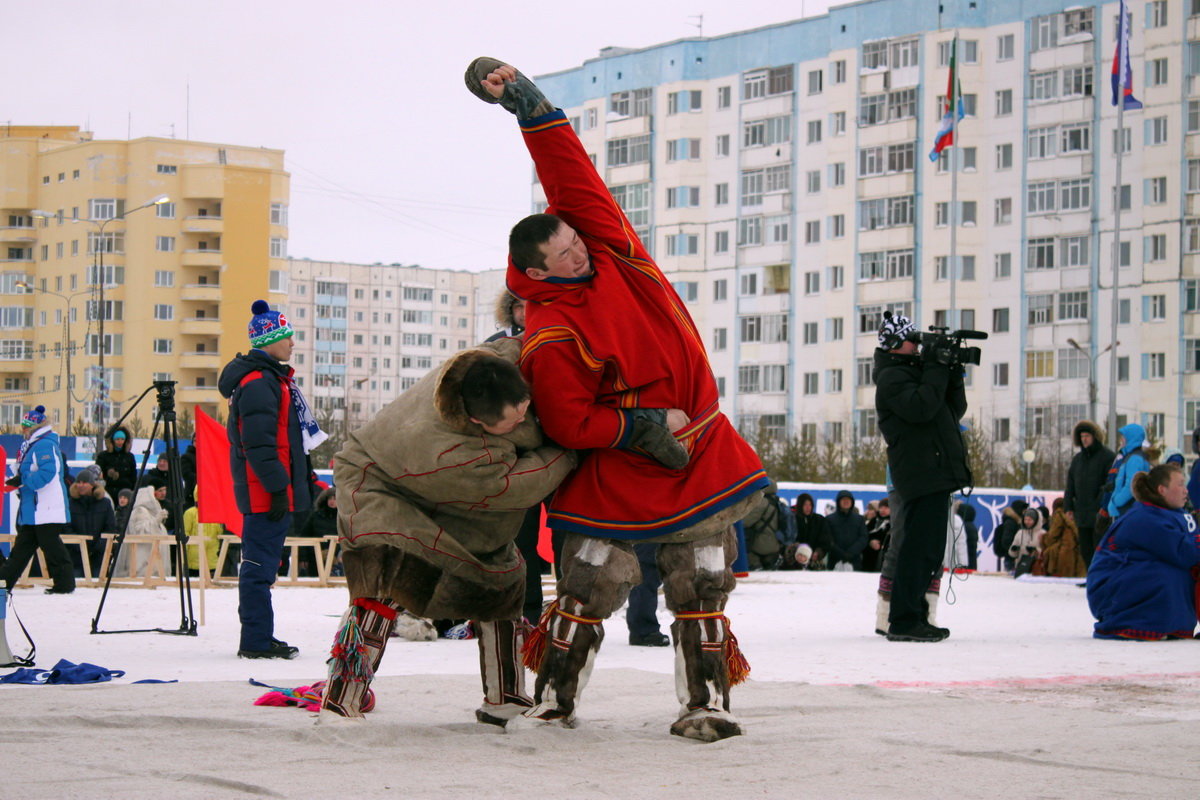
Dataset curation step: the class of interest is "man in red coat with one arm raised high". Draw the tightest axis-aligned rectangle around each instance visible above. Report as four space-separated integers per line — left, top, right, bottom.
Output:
466 59 768 741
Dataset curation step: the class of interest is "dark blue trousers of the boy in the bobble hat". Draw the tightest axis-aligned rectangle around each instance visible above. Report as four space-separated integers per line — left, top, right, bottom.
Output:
238 513 292 651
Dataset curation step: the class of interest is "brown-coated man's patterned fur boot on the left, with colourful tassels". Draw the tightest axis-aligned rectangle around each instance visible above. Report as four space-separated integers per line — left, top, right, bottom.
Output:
320 597 400 718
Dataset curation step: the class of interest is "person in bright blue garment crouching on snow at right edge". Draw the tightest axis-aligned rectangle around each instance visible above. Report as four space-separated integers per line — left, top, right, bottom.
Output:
1087 464 1200 642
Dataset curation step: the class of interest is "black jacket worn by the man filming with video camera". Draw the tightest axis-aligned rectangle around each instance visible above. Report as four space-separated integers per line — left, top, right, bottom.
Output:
875 348 972 499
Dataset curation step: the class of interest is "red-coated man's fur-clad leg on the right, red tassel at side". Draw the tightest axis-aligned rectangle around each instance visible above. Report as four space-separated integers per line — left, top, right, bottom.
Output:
659 529 744 741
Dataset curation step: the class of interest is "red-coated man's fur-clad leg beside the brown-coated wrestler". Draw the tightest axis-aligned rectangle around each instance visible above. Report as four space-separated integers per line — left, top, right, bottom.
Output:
526 534 641 727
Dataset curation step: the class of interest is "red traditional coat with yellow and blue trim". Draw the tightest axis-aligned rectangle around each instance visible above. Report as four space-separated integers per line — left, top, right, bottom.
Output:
508 112 768 540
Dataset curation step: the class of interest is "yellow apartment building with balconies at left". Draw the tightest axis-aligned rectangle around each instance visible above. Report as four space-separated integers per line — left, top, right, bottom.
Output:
0 126 289 431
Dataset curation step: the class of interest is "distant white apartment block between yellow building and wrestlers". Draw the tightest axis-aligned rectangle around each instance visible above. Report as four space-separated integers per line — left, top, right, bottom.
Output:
280 258 504 429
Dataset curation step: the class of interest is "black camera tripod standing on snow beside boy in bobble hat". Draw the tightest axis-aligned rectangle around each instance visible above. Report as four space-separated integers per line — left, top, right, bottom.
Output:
91 380 196 636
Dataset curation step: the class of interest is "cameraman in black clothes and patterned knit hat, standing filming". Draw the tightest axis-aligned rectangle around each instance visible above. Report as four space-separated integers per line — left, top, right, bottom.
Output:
875 312 971 642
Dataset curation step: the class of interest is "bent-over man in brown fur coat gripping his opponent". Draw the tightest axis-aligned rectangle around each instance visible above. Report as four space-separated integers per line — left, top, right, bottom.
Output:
322 338 576 726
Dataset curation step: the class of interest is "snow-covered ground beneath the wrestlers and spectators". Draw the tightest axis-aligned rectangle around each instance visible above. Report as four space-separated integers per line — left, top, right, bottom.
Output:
0 572 1200 799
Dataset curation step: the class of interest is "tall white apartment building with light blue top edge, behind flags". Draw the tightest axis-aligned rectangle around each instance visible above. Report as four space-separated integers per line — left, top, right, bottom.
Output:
533 0 1200 450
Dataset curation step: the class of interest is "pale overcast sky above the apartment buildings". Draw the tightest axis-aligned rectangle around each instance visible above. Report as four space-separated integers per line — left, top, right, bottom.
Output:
7 0 832 270
